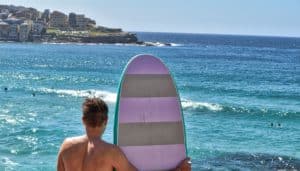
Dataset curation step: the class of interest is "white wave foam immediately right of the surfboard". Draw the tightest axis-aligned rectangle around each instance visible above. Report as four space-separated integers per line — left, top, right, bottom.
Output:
181 100 223 111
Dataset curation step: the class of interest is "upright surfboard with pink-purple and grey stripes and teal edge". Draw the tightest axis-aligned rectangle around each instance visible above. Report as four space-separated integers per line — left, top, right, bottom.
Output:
114 55 187 170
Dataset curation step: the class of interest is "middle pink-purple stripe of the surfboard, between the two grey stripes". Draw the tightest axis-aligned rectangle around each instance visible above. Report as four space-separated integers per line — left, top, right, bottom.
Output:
119 97 181 123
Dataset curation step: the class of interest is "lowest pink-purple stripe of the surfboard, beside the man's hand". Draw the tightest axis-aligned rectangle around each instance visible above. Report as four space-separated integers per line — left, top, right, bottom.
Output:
121 144 186 170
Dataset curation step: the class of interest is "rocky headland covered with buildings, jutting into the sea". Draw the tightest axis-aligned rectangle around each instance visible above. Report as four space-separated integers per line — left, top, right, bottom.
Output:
0 4 177 46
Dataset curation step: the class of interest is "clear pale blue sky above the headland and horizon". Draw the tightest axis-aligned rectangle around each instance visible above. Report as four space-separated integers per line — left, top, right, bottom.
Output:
0 0 300 37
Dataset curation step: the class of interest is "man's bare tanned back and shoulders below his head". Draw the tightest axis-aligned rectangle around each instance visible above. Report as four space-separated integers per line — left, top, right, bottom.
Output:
57 136 136 171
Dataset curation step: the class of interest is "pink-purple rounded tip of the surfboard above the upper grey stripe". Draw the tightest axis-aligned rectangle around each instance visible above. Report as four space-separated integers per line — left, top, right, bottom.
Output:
126 55 169 74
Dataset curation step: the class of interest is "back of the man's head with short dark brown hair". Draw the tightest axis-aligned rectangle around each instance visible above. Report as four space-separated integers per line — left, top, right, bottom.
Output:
82 98 108 132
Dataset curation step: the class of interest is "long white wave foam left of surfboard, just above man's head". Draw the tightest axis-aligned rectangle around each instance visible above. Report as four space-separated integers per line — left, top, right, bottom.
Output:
37 88 117 103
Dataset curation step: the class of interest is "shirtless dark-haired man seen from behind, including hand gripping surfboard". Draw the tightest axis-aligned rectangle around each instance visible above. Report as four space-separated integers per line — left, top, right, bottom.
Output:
57 98 191 171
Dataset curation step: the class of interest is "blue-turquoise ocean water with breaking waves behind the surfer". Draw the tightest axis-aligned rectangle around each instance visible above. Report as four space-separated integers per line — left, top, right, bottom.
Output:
0 32 300 171
